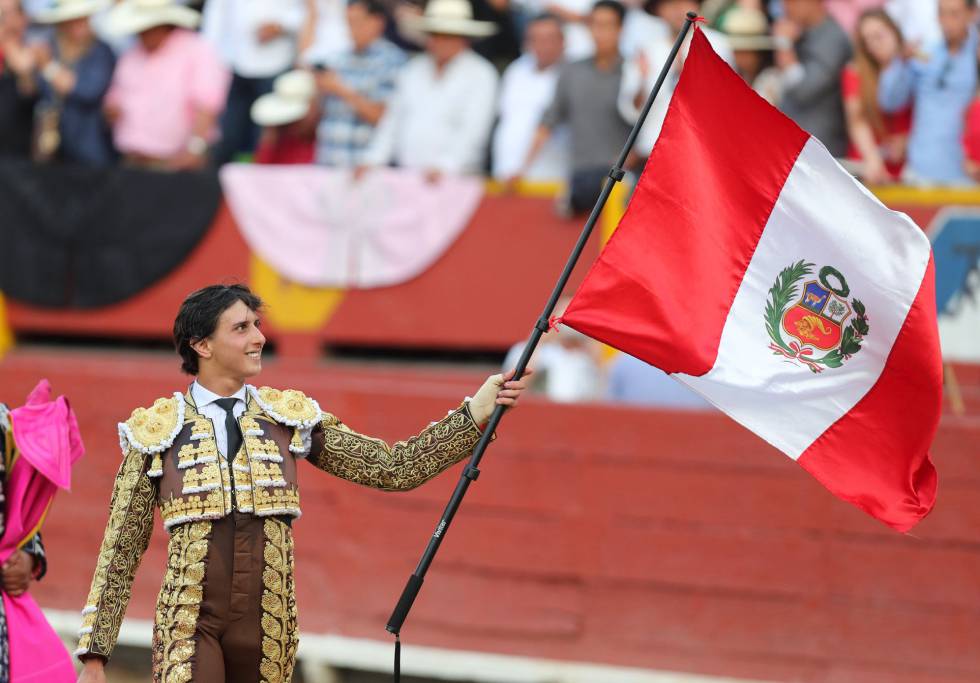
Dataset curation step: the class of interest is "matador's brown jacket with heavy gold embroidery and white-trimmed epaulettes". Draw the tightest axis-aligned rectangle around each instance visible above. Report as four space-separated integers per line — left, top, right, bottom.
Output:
75 385 480 659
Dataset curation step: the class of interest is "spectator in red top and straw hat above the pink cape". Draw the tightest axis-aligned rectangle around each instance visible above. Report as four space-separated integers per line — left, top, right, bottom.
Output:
251 70 320 164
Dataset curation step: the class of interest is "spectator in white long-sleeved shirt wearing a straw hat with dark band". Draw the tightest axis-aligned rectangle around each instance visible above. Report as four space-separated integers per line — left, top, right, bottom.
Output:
364 0 498 181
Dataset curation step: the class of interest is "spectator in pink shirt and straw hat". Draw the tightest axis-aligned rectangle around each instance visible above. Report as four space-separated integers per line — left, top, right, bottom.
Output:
106 0 230 170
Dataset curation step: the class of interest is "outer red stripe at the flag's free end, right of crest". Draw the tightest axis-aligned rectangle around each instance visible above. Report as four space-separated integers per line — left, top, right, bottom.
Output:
799 256 943 531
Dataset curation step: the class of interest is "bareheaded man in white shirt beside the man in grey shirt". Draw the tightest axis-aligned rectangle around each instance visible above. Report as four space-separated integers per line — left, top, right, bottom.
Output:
492 14 569 181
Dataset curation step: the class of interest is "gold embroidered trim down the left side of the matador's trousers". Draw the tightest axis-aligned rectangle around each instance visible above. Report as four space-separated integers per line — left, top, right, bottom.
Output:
153 522 211 683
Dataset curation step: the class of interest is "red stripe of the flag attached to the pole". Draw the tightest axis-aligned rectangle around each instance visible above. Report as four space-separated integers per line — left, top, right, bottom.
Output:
562 29 809 376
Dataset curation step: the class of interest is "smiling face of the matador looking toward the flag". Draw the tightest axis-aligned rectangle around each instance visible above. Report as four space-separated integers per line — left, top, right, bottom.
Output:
193 301 265 382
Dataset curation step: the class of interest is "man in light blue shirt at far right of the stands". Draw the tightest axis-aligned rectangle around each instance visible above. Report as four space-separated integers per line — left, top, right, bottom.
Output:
878 0 977 185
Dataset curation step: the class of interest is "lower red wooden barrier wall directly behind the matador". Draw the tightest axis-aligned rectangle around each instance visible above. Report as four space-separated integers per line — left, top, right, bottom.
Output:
0 351 980 683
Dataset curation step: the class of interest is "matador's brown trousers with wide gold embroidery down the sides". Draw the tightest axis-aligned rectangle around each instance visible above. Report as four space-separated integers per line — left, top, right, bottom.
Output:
153 512 298 683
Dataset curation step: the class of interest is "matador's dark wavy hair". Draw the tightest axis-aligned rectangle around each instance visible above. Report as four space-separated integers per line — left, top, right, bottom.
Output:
174 285 262 375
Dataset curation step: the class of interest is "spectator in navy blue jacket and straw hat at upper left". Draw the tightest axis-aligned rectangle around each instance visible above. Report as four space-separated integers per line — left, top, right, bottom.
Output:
35 0 116 166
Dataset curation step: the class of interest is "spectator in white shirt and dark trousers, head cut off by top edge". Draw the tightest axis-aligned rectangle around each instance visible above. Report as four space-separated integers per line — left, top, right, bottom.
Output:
201 0 306 164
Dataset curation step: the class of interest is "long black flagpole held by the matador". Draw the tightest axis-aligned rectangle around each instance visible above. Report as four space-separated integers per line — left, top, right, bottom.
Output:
385 12 698 681
